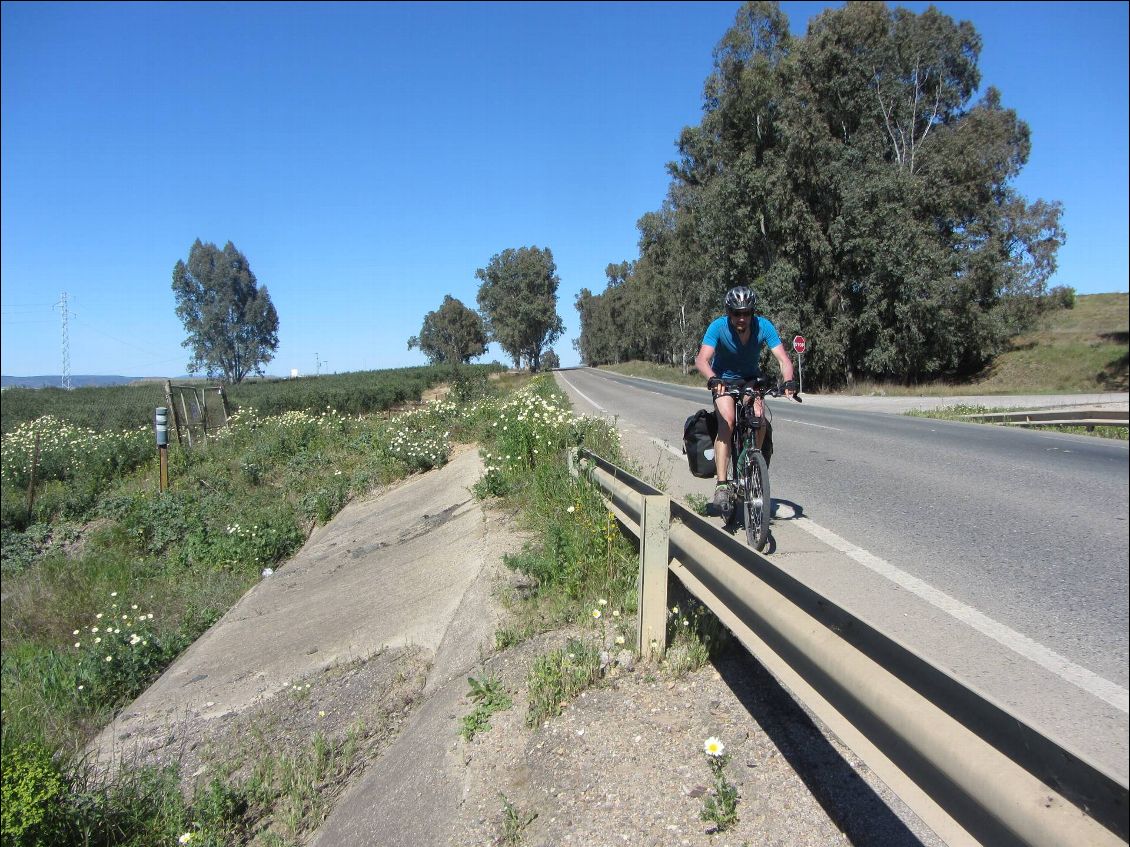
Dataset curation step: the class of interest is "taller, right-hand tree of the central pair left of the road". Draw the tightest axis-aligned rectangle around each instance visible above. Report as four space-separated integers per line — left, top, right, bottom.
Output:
475 247 565 370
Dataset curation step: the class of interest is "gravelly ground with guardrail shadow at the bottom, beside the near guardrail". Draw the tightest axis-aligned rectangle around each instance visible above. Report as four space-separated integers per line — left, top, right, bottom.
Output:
451 618 940 847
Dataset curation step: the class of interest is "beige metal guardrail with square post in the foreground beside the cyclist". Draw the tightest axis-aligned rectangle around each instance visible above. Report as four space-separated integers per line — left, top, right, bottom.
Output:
574 449 1130 847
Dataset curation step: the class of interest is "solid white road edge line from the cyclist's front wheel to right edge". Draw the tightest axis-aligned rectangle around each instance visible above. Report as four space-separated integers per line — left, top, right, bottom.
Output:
782 515 1130 714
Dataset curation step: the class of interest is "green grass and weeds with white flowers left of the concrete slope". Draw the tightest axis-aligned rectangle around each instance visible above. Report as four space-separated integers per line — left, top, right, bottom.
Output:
0 375 513 847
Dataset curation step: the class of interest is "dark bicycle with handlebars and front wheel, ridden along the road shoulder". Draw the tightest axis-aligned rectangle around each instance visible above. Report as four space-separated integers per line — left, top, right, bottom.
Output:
715 377 801 552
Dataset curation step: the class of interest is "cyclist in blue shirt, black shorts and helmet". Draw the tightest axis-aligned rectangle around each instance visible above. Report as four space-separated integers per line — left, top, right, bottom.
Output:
695 286 797 513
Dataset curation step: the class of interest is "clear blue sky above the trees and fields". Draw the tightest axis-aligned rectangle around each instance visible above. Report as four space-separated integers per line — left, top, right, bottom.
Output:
0 2 1130 376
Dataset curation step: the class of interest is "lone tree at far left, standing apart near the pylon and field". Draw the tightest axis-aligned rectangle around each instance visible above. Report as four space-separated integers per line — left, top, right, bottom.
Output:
173 238 279 384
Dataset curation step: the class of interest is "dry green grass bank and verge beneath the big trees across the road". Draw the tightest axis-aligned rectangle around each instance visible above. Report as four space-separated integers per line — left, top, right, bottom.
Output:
602 294 1130 396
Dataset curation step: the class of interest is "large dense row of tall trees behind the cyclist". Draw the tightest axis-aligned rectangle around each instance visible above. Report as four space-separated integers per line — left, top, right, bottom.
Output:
574 1 1074 386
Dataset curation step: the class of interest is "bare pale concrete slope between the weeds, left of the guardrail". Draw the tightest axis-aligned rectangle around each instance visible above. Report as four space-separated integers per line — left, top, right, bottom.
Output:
92 448 498 763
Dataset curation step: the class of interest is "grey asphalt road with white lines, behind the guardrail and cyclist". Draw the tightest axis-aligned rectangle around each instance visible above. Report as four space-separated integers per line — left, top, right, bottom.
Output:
558 369 1130 780
